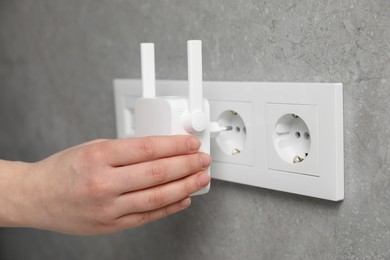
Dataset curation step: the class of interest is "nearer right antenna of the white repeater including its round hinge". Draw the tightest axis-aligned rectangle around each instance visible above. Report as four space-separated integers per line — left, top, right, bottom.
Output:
185 40 208 132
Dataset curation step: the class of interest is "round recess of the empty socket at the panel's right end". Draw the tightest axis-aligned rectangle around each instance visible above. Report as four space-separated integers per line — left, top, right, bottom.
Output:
273 113 311 164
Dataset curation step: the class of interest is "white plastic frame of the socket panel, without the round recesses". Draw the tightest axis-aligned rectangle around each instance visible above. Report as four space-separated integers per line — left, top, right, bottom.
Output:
114 79 344 201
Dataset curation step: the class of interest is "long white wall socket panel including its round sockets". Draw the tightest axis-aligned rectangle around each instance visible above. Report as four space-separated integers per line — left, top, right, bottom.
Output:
114 79 344 201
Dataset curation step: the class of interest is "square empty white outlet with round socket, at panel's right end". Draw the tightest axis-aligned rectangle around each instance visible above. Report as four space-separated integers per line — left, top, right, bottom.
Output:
266 103 320 176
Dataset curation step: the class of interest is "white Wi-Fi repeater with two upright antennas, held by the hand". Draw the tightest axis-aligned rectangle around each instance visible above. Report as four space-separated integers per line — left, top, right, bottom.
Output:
135 40 210 195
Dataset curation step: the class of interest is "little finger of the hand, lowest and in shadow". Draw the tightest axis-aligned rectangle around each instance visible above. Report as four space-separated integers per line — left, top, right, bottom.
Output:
117 197 191 229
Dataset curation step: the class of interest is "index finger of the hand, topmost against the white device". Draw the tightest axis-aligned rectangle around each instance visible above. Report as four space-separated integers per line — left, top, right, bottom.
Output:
99 135 200 166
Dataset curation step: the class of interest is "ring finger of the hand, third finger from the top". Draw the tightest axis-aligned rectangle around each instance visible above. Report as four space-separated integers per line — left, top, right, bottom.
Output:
115 172 210 216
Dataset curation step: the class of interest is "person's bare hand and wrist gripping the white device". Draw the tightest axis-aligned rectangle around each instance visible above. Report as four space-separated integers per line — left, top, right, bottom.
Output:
0 136 211 235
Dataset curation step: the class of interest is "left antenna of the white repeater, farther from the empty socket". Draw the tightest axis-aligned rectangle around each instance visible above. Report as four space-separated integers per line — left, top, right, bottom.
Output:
141 43 156 98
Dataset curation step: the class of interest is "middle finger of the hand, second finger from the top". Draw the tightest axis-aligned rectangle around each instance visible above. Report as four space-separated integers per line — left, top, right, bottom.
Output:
111 153 211 194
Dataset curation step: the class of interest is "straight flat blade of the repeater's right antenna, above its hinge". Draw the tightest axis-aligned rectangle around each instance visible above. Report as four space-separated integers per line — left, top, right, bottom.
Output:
187 40 203 114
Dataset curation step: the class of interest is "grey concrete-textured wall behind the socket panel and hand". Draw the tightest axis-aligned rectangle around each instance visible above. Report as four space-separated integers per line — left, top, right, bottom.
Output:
0 0 390 259
